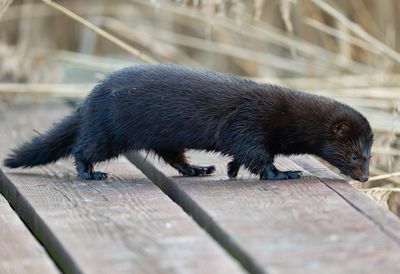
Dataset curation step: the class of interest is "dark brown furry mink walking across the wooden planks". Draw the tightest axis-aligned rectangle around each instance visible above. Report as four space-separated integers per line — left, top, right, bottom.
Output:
4 65 373 182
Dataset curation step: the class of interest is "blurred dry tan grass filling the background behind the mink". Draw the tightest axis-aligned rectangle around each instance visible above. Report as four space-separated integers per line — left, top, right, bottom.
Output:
0 0 400 214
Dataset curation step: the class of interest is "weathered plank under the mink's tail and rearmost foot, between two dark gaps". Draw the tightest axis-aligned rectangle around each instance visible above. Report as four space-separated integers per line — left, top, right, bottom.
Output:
0 104 243 273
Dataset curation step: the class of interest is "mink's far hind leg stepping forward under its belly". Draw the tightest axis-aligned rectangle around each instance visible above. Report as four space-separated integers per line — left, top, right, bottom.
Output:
155 149 215 176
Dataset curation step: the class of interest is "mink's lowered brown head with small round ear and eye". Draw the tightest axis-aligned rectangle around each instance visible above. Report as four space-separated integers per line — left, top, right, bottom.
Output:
324 113 374 182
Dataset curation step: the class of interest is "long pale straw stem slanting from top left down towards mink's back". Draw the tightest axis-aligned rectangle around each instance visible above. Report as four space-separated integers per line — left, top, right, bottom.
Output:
42 0 157 64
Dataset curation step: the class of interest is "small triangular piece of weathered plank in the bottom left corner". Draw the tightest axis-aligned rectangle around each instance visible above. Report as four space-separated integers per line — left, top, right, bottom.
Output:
0 195 60 274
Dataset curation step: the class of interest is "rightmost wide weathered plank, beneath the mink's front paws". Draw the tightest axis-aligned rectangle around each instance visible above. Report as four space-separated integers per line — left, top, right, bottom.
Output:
126 150 400 273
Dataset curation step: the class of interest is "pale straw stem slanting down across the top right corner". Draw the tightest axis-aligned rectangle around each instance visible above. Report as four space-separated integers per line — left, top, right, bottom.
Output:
311 0 400 63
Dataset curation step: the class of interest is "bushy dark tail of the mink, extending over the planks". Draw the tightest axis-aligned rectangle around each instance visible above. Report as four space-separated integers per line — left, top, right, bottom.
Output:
4 112 79 168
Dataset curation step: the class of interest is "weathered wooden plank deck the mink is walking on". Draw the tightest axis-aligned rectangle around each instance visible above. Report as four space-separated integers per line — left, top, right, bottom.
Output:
0 101 400 273
